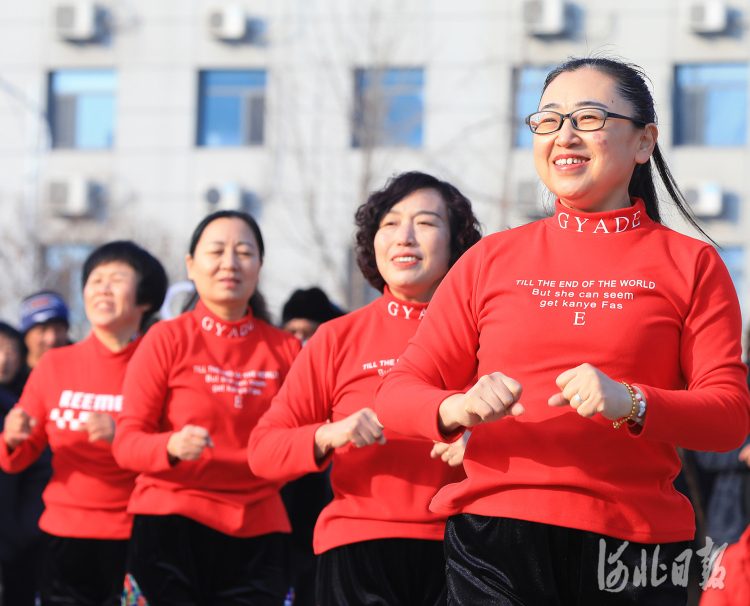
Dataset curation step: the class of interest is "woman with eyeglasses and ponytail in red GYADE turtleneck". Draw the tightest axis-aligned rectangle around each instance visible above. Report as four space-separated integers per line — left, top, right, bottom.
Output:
376 58 750 606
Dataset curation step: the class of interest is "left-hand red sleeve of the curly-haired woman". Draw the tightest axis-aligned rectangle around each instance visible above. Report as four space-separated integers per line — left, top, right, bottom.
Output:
248 324 336 481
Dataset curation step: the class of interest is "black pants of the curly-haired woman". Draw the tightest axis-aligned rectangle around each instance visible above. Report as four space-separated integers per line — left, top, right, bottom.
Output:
317 539 446 606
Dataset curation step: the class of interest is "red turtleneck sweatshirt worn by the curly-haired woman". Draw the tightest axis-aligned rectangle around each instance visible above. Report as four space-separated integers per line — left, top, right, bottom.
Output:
248 289 465 553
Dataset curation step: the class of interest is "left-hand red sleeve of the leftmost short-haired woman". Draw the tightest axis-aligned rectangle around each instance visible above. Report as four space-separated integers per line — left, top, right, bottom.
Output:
0 356 49 473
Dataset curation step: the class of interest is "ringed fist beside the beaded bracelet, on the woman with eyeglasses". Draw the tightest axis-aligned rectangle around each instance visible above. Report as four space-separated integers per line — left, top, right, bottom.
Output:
548 364 633 421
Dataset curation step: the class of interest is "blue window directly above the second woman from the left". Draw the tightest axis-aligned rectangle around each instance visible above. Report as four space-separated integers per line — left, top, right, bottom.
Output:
198 70 266 147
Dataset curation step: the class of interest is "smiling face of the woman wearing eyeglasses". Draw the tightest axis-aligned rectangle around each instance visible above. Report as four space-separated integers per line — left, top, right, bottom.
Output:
534 68 658 212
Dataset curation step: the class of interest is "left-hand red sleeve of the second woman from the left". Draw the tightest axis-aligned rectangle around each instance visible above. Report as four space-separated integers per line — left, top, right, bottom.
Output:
112 324 178 473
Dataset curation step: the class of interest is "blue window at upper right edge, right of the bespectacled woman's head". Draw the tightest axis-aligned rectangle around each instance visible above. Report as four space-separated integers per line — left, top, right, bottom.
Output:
674 63 748 146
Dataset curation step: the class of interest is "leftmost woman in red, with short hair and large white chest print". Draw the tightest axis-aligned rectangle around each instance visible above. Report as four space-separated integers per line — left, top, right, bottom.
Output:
0 242 167 606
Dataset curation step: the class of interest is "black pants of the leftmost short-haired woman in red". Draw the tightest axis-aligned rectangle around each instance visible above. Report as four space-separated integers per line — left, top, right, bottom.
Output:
39 533 128 606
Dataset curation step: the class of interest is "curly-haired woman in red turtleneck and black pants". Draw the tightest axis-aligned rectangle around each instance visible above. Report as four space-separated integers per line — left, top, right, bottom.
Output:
249 172 480 606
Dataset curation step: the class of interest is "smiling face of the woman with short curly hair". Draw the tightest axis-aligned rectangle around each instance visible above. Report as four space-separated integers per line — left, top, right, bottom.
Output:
374 189 451 303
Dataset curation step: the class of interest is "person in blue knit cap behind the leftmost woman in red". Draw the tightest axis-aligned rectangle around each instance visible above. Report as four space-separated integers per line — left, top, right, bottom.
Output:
20 291 70 372
